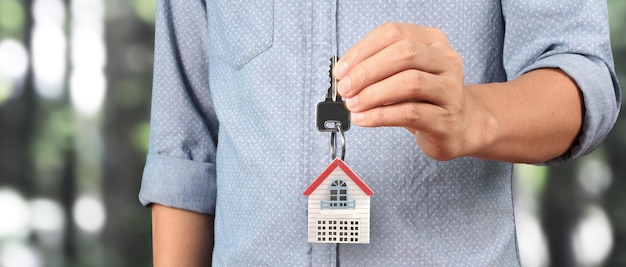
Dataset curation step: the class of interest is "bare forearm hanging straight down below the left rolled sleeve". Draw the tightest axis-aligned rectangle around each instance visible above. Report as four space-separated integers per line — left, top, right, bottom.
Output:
152 204 214 267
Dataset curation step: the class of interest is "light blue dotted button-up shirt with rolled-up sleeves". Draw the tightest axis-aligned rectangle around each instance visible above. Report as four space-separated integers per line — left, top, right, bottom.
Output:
139 0 620 266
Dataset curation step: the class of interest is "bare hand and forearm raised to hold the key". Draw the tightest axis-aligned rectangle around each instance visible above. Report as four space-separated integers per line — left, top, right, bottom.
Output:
335 23 583 162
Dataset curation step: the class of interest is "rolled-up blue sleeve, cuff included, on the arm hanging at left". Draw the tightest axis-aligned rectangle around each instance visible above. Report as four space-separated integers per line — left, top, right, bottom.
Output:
139 0 219 214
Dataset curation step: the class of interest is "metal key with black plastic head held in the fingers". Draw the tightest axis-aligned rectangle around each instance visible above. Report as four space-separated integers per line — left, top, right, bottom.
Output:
315 56 350 132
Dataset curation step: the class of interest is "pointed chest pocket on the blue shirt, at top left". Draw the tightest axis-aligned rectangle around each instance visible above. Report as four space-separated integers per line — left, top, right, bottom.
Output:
207 0 274 69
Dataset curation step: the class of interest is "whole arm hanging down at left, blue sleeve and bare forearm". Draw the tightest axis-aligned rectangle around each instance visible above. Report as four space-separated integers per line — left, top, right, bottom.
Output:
139 0 219 266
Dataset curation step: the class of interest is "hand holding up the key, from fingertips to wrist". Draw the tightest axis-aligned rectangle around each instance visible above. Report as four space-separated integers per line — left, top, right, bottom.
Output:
334 23 495 160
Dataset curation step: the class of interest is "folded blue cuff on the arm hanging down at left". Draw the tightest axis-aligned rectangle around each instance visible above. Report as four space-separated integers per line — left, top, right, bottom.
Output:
139 153 217 214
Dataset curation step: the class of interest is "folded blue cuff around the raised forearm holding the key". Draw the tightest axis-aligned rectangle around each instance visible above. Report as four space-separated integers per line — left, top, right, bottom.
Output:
524 54 620 165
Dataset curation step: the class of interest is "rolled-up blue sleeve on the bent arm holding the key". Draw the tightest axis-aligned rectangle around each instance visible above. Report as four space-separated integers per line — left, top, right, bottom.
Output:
502 0 621 164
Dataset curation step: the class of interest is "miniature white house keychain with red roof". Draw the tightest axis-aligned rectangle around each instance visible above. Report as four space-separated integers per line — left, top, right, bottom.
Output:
303 158 374 244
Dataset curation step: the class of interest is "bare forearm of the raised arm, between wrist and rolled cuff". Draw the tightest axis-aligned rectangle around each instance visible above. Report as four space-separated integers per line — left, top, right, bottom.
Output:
466 69 584 163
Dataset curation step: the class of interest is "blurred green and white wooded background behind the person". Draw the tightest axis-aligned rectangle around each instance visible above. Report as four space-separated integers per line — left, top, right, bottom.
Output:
0 0 626 267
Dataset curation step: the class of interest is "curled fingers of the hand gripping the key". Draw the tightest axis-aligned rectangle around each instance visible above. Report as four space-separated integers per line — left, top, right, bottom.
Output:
334 23 463 119
